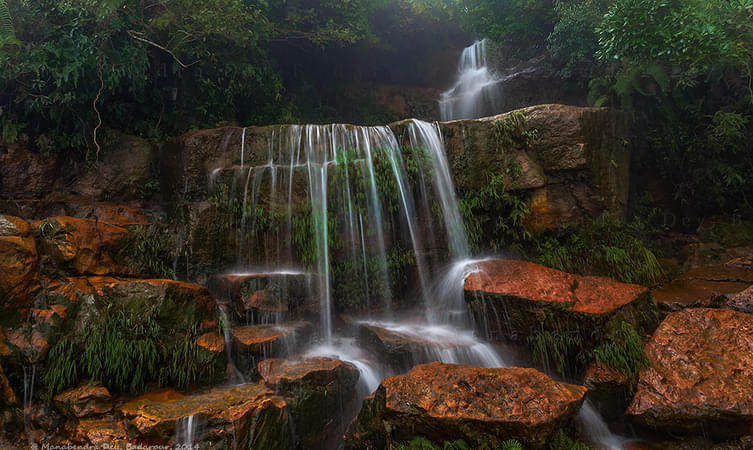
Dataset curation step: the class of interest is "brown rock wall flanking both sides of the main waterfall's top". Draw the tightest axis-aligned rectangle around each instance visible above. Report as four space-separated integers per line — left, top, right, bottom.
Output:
160 105 631 228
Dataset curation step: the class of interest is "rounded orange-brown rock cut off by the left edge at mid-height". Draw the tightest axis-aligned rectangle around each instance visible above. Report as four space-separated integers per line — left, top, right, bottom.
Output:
0 215 39 308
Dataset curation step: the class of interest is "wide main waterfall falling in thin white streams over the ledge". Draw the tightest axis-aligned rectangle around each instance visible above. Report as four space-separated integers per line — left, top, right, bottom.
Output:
210 117 624 450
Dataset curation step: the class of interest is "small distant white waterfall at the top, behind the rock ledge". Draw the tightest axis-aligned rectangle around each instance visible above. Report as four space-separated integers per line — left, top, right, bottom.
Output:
439 39 501 121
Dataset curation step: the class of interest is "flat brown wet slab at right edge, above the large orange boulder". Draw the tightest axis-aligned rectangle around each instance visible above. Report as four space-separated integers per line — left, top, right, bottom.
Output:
652 263 753 311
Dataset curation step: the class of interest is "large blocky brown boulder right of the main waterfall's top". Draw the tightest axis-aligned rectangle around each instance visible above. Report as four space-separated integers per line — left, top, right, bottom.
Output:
432 105 631 229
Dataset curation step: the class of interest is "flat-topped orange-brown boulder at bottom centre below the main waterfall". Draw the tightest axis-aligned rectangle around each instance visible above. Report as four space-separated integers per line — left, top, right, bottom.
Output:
346 362 586 448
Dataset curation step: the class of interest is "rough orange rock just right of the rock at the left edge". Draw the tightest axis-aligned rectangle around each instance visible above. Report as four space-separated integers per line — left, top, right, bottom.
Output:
38 216 131 275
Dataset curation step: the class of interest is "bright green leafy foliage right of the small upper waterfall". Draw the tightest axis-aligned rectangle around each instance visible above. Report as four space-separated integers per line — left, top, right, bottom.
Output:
460 0 753 215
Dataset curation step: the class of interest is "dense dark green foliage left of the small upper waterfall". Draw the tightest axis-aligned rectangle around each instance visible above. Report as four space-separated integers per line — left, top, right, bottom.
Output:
0 0 462 161
